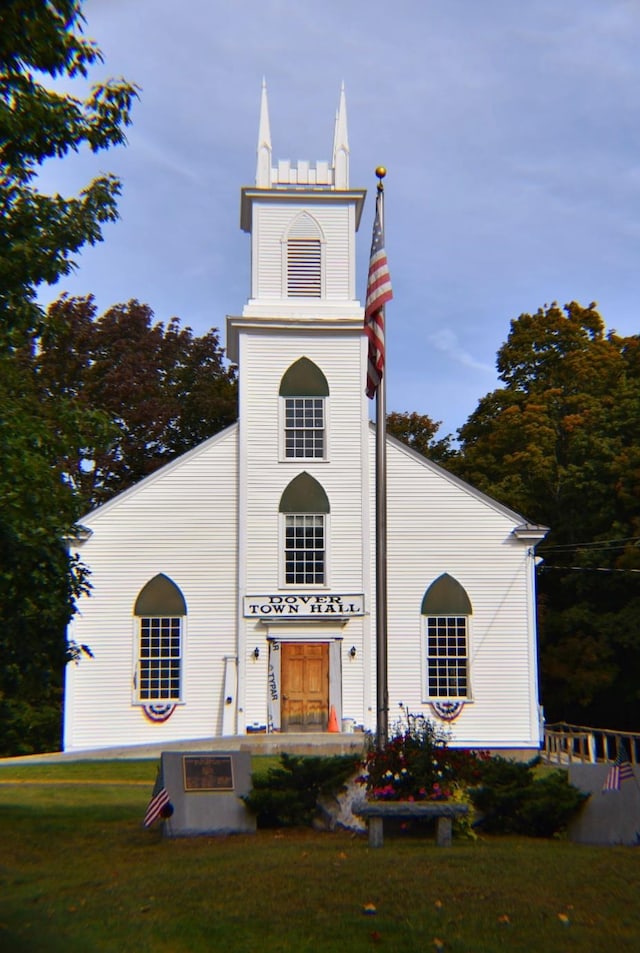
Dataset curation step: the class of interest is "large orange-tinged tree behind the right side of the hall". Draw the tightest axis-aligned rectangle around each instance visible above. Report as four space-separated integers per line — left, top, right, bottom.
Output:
452 302 640 728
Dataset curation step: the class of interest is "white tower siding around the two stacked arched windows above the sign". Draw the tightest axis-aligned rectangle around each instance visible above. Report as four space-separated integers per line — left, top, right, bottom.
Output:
241 332 366 592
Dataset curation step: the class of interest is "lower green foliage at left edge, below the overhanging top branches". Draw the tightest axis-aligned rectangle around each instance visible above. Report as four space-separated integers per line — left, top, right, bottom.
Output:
0 342 110 755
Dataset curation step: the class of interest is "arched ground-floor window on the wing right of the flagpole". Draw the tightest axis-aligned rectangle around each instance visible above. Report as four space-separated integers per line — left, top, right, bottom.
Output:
421 573 473 702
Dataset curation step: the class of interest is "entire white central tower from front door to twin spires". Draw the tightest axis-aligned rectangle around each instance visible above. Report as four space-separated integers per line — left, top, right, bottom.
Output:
227 84 372 731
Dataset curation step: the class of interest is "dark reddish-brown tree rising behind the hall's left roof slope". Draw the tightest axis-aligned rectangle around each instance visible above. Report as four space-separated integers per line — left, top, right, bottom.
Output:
37 296 237 509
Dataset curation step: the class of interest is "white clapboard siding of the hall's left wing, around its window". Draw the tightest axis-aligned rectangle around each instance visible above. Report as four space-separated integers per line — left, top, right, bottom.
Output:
65 426 237 749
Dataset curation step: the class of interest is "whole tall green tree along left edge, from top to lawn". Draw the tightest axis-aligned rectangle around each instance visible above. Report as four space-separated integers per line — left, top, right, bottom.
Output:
0 0 136 754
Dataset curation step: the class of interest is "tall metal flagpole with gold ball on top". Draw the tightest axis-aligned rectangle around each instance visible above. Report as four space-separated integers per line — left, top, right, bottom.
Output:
376 166 389 751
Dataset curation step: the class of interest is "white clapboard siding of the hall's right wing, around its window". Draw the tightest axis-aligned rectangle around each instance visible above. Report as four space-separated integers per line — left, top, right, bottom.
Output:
371 434 539 747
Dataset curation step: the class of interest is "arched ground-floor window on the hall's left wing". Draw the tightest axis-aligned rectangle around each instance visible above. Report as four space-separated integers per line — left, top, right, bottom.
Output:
133 573 187 706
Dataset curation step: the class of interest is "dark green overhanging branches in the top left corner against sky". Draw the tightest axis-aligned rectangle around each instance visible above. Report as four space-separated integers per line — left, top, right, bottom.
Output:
0 0 136 342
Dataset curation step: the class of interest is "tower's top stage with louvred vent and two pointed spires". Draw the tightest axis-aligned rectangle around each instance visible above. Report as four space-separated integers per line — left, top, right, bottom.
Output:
227 81 366 361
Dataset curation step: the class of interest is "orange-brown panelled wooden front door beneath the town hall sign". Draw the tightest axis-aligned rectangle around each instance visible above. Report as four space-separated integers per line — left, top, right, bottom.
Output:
280 642 329 731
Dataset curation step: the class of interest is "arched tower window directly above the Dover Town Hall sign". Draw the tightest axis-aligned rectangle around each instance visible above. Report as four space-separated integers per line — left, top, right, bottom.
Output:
280 473 330 586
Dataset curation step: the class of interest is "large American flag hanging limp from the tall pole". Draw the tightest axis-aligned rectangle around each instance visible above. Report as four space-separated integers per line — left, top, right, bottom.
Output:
364 191 393 398
